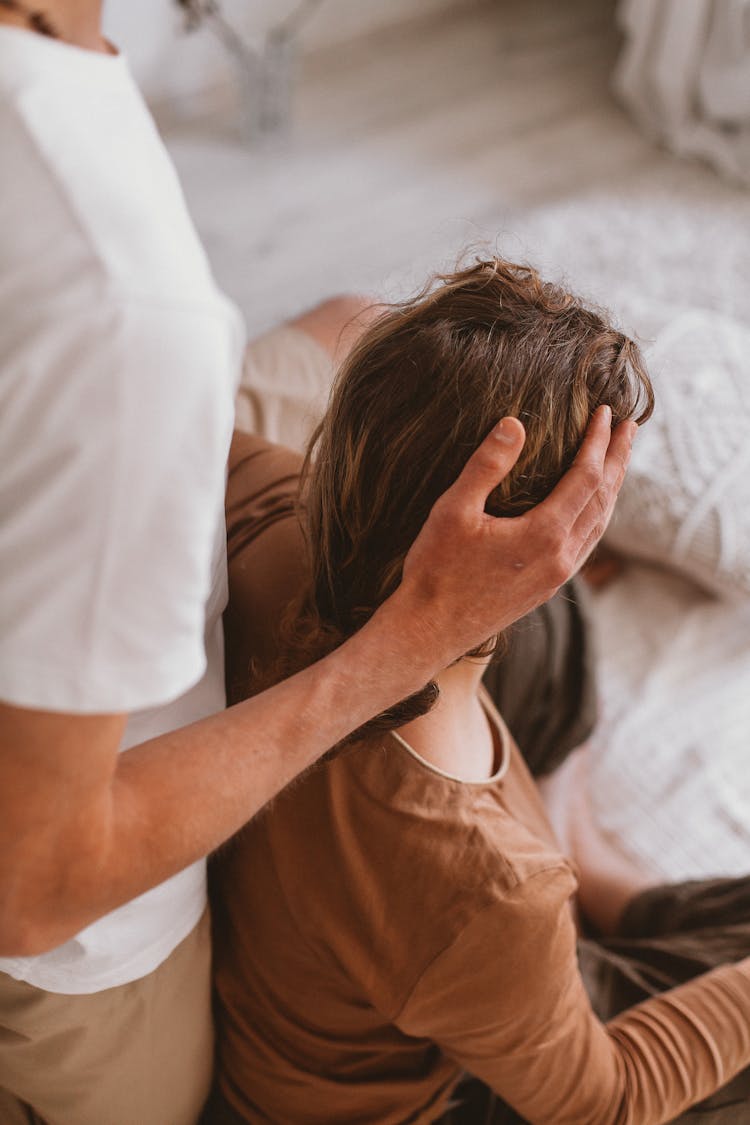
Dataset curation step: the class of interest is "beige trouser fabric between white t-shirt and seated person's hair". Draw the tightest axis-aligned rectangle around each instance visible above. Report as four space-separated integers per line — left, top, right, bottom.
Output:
235 324 334 450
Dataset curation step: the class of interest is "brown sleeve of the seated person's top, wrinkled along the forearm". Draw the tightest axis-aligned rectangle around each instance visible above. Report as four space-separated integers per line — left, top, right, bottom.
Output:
397 870 750 1125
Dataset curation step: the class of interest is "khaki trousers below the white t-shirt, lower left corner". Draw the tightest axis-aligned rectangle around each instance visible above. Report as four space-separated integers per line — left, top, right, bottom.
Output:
0 911 214 1125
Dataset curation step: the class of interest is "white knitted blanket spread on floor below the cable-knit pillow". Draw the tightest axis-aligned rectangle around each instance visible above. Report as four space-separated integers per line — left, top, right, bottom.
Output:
587 565 750 881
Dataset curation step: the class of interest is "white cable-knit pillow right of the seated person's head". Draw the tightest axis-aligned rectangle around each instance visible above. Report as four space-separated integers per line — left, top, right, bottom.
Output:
606 311 750 601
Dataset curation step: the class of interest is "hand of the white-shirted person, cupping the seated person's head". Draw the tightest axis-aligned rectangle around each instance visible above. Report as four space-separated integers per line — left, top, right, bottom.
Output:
394 406 638 665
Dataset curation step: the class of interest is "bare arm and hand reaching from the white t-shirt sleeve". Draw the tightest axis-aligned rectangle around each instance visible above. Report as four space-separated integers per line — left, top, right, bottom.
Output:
0 407 634 956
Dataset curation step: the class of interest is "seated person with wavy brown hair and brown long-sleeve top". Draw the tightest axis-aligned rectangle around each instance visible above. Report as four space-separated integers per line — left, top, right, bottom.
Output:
207 259 750 1125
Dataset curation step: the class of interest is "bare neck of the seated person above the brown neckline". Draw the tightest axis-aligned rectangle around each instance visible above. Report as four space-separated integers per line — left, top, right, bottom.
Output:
398 657 496 781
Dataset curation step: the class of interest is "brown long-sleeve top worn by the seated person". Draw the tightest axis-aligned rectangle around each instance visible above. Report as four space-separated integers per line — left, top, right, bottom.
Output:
214 434 750 1125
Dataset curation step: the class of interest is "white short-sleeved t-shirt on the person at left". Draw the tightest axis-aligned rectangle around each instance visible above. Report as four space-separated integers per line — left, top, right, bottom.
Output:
0 27 243 992
